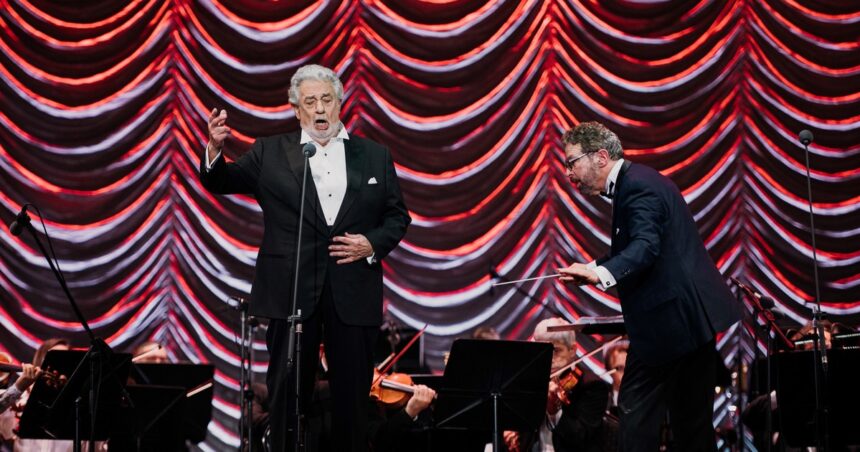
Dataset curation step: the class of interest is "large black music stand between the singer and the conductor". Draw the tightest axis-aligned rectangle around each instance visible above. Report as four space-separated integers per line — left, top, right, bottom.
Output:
434 339 552 451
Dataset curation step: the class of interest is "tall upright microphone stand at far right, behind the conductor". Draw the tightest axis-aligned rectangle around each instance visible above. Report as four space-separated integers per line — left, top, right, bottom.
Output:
798 130 830 451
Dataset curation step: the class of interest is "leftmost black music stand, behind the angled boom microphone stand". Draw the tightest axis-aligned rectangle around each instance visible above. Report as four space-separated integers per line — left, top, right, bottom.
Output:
18 350 131 441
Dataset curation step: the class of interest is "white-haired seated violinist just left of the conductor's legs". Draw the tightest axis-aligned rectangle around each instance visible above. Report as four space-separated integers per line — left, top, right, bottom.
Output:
504 318 609 452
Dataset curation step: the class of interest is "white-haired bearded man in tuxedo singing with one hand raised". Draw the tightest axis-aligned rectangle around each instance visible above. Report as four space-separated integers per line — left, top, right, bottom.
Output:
205 65 411 451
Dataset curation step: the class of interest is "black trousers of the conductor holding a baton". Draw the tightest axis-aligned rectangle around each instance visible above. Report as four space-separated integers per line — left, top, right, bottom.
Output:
618 340 717 452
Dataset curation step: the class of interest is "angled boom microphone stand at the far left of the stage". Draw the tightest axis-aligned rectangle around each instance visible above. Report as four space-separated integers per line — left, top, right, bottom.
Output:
10 204 123 452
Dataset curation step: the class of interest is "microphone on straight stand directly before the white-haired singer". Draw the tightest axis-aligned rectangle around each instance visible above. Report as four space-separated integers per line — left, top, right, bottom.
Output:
287 143 317 452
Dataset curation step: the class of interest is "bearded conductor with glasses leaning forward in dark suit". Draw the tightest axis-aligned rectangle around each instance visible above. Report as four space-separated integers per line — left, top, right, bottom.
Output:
559 122 740 451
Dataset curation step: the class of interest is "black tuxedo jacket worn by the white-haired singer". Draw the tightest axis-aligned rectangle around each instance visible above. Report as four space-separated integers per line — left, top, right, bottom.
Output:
205 132 411 326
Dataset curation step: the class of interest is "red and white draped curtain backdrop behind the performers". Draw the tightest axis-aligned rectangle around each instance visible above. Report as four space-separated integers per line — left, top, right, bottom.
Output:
0 0 860 450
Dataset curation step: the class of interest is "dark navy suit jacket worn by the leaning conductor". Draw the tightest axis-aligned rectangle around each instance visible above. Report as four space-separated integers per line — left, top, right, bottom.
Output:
597 162 740 365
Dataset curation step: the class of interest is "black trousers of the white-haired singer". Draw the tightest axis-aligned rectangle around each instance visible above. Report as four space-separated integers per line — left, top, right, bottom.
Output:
266 280 379 452
